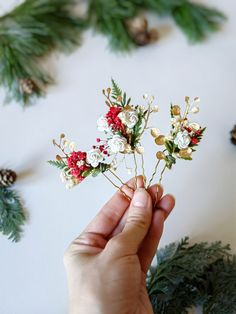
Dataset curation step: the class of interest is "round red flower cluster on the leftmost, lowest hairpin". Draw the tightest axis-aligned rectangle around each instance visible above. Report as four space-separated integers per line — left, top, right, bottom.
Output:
67 151 90 182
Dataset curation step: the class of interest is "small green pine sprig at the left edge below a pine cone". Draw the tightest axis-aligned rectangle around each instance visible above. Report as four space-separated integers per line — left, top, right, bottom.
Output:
0 188 26 242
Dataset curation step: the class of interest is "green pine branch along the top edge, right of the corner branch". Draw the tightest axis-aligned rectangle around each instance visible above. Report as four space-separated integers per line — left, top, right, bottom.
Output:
89 0 225 51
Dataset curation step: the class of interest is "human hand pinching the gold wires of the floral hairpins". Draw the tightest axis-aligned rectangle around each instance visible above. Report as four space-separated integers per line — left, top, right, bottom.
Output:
64 177 175 314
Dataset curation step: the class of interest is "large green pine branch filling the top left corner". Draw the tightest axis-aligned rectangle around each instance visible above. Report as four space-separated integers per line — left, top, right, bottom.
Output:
0 0 85 105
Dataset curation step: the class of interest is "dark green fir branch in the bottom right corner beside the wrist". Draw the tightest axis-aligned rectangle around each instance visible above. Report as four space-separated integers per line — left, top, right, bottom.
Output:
147 238 236 314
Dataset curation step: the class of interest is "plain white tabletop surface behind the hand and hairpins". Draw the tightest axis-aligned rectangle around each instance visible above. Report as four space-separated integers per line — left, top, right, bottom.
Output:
0 0 236 314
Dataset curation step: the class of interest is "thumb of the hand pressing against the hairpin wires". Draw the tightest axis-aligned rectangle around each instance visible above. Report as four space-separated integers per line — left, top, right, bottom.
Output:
108 188 152 256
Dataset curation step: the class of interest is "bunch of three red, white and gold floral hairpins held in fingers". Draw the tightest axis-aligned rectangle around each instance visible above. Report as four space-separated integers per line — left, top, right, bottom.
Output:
49 80 205 194
